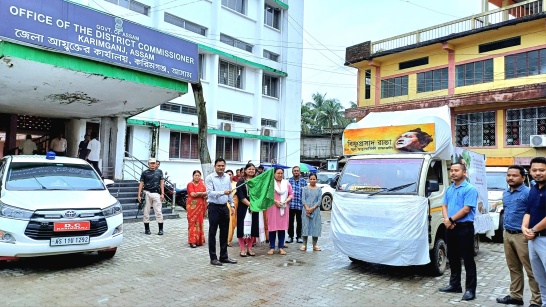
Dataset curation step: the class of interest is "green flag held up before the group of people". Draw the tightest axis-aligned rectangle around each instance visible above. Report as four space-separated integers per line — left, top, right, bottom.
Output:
246 168 275 212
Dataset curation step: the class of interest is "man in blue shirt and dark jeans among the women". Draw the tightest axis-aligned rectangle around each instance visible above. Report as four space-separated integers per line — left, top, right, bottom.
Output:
286 166 307 243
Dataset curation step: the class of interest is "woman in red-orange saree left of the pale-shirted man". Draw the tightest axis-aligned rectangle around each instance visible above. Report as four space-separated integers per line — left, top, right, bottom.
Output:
186 170 207 248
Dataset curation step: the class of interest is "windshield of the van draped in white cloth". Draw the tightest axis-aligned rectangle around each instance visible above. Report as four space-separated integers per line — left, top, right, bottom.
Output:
338 159 423 194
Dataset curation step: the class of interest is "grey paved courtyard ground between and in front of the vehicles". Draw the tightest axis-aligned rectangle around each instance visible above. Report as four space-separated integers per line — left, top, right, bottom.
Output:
0 211 530 306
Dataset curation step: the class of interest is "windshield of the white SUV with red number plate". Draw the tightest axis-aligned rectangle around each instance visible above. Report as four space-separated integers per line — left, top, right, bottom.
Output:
6 162 105 191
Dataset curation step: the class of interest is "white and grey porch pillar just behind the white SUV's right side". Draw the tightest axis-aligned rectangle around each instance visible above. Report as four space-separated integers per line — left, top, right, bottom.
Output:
99 117 127 180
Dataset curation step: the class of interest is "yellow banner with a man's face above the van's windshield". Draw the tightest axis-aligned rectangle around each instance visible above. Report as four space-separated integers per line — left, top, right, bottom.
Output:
343 123 436 155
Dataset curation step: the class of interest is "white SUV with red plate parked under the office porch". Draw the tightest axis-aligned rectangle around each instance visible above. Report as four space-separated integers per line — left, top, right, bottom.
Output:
0 155 123 261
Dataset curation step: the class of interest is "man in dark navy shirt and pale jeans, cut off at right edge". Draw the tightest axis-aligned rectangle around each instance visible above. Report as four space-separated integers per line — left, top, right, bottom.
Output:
521 157 546 306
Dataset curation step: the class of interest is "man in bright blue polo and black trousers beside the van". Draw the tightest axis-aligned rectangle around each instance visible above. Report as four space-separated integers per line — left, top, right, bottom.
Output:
439 162 478 301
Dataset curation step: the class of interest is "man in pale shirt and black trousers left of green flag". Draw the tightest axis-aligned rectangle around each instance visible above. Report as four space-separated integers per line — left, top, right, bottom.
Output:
205 158 237 265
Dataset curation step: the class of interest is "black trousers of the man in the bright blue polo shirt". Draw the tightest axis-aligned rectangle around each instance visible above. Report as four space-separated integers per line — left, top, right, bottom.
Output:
446 223 477 291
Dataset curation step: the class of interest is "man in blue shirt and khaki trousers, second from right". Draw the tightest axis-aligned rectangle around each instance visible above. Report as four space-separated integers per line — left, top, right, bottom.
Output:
497 165 542 307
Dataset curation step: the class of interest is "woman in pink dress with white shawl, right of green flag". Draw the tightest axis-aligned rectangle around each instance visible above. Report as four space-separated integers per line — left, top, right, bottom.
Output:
266 167 294 255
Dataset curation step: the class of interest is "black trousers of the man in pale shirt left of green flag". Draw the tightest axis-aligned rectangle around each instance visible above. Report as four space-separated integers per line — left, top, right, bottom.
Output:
209 203 230 260
